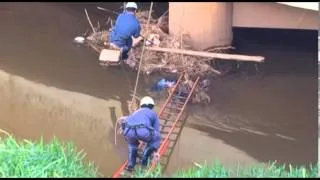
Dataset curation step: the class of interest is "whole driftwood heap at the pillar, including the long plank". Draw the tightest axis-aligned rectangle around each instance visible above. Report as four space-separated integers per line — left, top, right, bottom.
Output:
85 7 264 105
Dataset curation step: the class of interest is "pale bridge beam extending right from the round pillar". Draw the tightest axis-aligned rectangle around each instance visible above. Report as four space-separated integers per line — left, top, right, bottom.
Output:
232 2 319 30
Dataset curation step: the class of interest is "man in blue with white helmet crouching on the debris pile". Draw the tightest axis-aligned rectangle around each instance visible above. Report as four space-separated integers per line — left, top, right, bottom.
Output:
109 2 142 60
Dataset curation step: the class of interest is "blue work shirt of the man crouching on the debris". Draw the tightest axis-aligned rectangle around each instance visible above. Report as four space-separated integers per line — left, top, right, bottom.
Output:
110 12 141 50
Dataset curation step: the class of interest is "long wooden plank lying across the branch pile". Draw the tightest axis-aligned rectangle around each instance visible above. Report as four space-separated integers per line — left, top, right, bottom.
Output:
146 47 265 62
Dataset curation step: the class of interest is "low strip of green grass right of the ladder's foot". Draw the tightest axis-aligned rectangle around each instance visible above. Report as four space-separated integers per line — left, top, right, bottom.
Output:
135 161 318 178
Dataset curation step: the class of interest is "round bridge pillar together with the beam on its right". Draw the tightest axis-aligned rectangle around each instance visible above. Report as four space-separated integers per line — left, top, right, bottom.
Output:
169 2 319 49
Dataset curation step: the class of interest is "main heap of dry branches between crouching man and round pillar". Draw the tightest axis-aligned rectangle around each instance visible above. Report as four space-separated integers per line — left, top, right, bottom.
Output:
128 11 224 77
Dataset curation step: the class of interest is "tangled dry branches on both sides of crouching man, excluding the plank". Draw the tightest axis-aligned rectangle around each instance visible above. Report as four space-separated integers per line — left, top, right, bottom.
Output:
86 11 225 103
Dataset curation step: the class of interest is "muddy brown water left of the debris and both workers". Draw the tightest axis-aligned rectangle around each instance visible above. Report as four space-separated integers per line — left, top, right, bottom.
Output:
0 3 137 175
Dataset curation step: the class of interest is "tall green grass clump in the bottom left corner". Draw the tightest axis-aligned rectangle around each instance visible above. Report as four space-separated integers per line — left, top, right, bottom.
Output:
0 131 98 178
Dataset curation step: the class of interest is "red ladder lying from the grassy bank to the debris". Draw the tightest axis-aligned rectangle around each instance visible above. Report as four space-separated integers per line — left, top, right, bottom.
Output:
112 74 200 178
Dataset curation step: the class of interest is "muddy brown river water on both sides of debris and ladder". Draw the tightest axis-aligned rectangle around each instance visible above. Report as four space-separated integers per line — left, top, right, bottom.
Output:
0 3 317 176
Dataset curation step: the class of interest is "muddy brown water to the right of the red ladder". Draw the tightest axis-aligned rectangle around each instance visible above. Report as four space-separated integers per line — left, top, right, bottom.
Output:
165 29 318 172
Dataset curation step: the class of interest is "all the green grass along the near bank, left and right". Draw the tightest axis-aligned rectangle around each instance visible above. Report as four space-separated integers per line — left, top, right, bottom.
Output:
0 131 318 178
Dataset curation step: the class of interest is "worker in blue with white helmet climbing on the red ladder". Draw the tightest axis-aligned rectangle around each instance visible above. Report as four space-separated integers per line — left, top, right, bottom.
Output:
122 96 161 172
